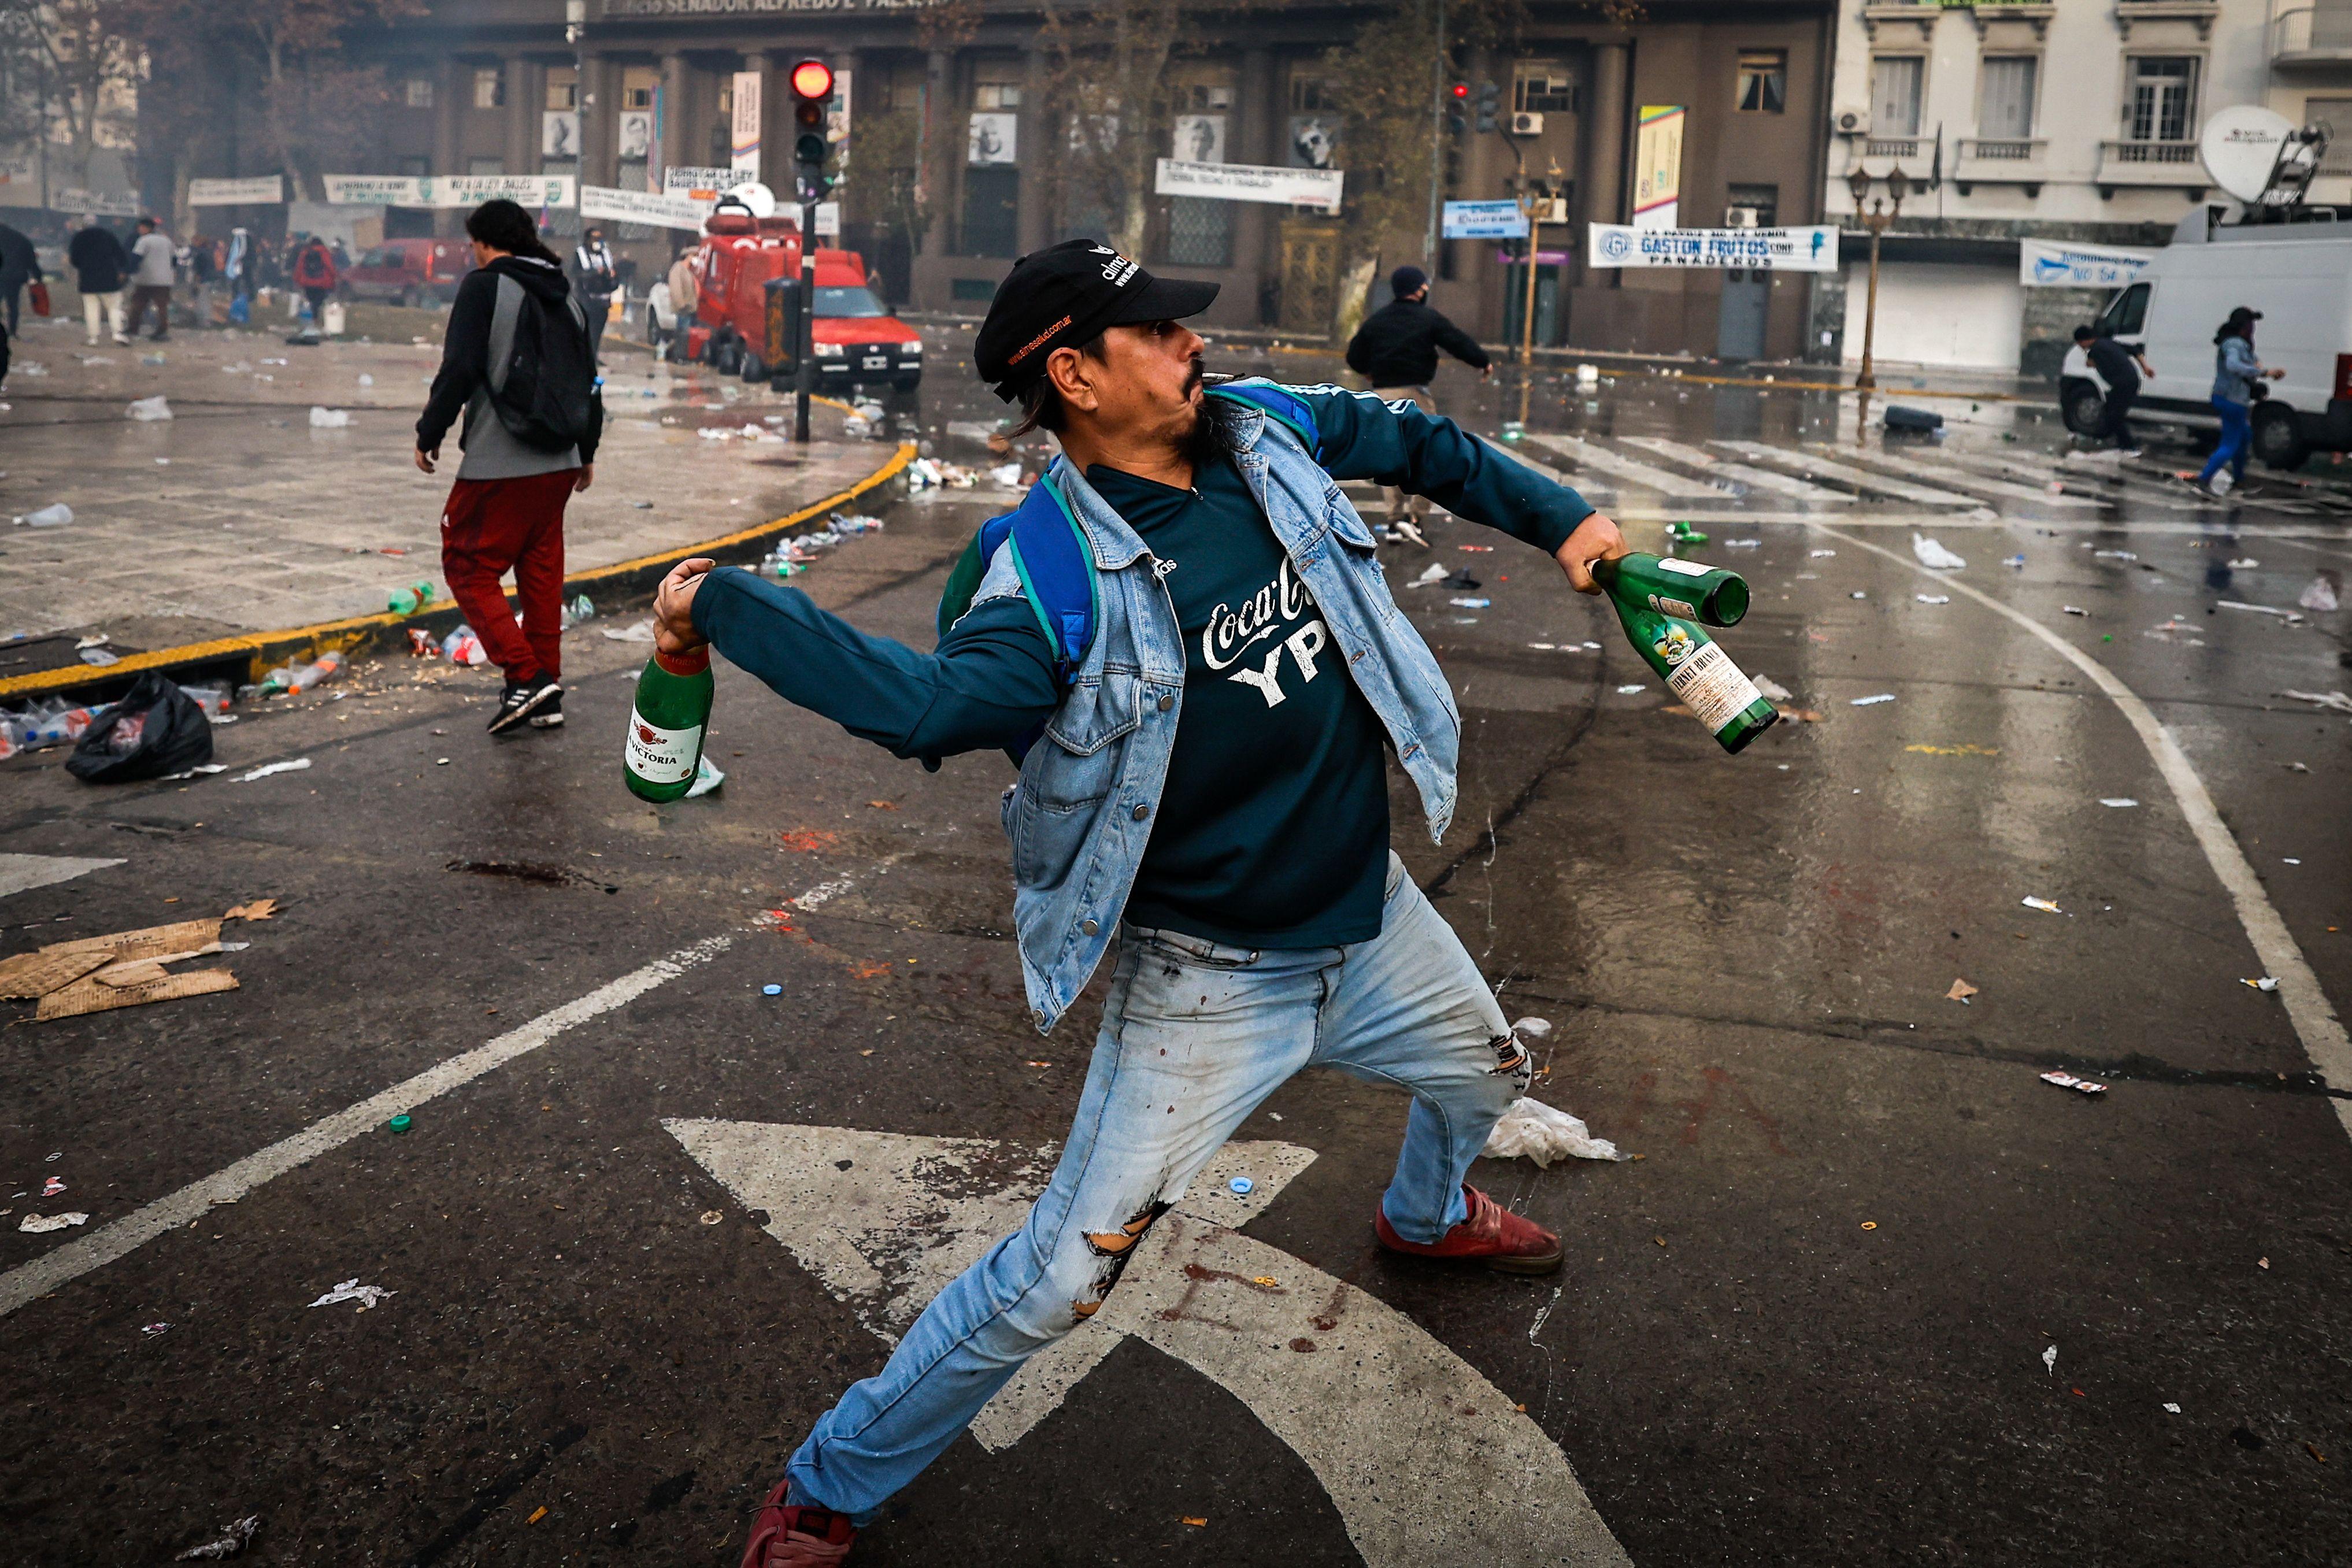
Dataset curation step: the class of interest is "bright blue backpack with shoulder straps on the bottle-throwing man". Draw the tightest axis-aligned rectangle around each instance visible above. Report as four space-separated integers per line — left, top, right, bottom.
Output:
939 381 1322 691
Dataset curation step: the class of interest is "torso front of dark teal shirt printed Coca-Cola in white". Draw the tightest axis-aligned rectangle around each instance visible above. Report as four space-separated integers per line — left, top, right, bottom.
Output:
1087 458 1388 947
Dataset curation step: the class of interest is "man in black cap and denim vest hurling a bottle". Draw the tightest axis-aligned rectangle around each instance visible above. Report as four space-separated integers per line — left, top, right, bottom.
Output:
656 240 1625 1568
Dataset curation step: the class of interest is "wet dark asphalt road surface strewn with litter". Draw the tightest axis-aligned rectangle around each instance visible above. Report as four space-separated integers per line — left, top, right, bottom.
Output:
0 355 2352 1566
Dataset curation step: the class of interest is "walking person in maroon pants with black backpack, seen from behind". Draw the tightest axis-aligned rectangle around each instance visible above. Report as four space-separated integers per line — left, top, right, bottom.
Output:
416 200 605 736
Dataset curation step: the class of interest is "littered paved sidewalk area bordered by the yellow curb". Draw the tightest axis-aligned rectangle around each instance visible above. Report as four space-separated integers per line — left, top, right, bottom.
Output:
0 317 894 651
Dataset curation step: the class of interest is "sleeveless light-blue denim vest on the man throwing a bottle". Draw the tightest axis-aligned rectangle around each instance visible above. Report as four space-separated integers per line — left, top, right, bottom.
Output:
974 405 1461 1032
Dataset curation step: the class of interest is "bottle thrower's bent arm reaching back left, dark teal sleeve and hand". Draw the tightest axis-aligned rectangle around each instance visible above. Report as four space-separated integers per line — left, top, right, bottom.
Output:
654 559 1061 759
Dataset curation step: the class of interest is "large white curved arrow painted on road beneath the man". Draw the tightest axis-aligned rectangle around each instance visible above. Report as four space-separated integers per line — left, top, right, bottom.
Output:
663 1119 1632 1568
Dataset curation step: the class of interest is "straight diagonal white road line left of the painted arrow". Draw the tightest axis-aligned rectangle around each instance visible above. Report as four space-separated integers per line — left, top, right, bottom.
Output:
0 936 734 1317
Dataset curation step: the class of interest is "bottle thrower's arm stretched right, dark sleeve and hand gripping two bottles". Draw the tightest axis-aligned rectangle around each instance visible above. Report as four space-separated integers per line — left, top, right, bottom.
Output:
1289 388 1625 592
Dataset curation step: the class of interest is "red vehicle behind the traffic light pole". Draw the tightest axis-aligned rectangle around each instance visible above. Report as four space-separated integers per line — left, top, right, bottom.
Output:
682 205 922 392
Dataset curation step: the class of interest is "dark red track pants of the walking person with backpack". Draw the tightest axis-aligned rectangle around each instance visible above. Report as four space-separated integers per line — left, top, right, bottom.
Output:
442 468 579 682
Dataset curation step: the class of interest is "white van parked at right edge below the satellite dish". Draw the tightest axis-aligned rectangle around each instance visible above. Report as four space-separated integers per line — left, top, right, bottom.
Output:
2058 205 2352 468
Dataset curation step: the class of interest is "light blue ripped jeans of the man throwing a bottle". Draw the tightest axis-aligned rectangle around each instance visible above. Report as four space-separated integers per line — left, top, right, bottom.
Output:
786 856 1529 1523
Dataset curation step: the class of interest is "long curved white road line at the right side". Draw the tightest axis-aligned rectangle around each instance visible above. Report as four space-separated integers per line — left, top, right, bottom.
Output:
1813 524 2352 1133
